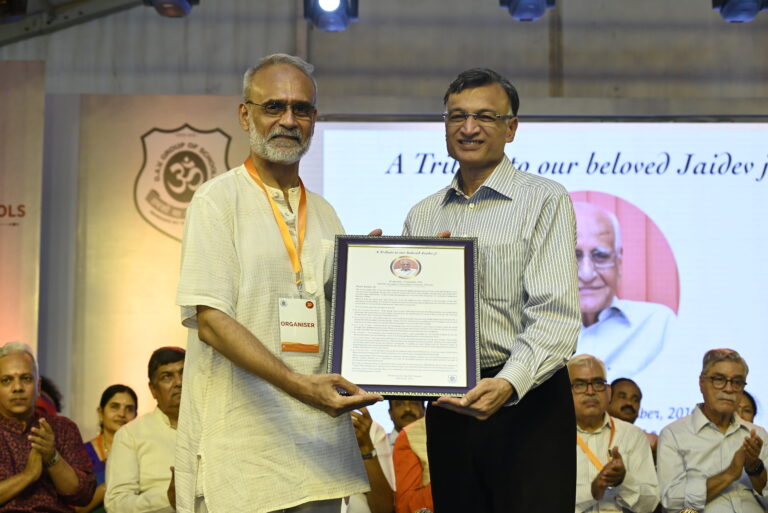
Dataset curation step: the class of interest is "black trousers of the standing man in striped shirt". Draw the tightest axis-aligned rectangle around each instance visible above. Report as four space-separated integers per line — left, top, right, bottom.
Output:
426 368 576 513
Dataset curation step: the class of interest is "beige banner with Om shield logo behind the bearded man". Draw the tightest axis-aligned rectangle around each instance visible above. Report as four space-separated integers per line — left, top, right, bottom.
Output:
73 96 248 425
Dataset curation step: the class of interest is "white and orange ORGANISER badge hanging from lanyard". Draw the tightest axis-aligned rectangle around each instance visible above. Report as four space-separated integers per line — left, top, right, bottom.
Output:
278 298 320 353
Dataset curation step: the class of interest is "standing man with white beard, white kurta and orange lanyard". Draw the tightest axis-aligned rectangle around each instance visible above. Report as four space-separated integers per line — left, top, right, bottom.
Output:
175 54 381 513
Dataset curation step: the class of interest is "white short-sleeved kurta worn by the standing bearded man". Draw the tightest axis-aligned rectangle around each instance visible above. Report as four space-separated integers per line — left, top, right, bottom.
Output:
176 166 368 513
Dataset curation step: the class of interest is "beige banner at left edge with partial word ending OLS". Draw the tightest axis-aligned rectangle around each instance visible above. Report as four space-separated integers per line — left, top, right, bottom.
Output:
0 61 45 348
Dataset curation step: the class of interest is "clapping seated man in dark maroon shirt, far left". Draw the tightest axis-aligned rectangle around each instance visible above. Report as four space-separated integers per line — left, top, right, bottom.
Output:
0 342 96 513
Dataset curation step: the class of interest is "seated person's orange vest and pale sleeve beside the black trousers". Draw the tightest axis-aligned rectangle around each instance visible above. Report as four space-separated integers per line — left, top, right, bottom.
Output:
393 417 435 513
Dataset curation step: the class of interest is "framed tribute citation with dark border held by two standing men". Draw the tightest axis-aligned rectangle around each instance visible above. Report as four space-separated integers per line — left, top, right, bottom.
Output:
329 235 480 397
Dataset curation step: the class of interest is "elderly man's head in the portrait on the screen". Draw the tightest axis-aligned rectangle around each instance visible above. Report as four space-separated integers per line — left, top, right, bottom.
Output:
573 201 622 326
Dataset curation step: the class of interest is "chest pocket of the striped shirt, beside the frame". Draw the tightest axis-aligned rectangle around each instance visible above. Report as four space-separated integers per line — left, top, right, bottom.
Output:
478 242 526 302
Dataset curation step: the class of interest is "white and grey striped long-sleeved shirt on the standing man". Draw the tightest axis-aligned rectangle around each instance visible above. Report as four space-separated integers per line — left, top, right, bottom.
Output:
403 156 581 404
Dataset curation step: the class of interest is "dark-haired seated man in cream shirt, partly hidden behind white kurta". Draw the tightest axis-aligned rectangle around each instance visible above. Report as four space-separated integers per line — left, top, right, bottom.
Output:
104 347 184 513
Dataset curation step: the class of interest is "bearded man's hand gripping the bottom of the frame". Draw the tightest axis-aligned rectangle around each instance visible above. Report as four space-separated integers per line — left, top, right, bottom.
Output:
286 374 384 417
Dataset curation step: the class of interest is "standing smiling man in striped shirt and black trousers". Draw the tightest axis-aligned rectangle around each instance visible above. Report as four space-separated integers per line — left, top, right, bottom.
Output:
404 69 581 513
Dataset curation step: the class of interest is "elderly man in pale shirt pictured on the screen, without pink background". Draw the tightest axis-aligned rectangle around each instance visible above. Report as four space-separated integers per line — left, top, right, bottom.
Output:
573 201 675 376
